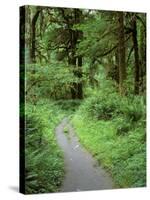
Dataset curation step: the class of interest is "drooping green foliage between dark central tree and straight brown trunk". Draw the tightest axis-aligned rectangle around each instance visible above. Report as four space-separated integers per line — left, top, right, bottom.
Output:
75 13 116 59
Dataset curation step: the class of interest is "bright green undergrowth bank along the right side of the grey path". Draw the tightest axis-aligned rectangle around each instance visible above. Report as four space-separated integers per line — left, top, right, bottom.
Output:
72 90 146 188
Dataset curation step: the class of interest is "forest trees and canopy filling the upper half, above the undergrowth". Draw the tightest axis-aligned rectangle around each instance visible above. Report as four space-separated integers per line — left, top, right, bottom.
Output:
22 6 146 99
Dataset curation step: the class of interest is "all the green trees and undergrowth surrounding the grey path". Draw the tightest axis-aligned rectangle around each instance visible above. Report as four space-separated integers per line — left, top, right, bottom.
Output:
20 6 146 193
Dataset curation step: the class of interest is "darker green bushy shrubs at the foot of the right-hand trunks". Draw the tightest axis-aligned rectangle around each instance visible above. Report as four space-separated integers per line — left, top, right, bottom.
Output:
80 85 146 135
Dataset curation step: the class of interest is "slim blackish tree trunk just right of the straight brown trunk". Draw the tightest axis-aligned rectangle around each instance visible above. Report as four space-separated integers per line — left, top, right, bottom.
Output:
132 16 140 94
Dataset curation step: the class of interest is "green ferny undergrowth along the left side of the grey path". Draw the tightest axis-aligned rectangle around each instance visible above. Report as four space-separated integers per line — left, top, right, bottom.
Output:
25 101 64 194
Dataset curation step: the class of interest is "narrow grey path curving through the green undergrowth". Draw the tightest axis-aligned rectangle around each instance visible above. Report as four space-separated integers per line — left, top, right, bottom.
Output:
56 118 113 192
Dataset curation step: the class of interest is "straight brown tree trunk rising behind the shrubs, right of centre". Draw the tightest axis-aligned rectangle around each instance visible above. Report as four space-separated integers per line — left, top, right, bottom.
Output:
118 12 126 95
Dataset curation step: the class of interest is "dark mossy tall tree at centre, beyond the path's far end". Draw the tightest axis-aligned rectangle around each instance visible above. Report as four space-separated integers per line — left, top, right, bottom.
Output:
61 9 83 99
